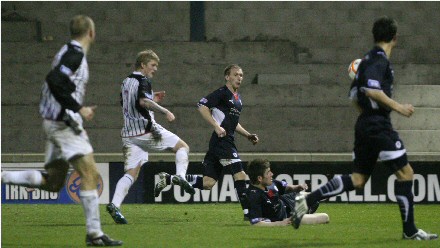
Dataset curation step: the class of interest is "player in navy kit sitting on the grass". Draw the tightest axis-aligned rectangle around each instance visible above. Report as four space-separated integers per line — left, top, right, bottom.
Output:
247 159 329 226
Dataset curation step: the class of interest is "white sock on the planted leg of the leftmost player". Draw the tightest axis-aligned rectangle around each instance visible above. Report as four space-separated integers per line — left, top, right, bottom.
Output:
79 189 104 237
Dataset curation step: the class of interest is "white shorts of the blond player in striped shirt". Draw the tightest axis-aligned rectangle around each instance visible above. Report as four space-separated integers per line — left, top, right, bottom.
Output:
122 124 180 171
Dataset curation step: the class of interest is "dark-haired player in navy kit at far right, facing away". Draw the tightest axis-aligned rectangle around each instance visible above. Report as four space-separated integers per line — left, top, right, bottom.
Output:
294 17 438 240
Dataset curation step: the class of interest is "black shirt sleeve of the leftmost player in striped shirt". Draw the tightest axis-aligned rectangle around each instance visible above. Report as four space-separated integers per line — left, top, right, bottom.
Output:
46 46 84 112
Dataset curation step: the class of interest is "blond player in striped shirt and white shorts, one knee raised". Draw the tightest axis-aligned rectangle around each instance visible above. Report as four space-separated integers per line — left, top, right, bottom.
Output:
107 50 195 224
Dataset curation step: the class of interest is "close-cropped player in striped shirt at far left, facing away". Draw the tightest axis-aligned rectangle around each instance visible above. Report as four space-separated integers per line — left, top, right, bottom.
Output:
2 15 122 246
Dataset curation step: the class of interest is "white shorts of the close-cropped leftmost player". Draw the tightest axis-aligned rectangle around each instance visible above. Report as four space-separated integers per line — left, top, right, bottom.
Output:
43 120 93 163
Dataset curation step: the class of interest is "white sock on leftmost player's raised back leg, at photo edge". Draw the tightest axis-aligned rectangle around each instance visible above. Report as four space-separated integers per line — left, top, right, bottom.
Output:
2 170 43 188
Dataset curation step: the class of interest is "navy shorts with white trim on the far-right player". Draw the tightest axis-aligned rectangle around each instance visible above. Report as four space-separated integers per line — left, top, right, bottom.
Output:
353 116 408 175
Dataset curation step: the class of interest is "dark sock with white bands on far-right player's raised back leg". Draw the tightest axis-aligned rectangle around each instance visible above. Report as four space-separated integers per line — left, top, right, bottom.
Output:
306 175 354 206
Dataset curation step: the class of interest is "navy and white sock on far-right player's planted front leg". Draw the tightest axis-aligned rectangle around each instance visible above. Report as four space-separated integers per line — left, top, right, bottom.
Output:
394 181 417 236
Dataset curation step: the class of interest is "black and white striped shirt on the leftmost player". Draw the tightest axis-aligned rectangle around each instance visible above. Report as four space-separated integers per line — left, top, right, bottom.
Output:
40 40 89 123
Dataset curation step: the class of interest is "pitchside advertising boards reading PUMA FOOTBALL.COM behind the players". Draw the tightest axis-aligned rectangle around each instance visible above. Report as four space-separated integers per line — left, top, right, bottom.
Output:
2 153 440 204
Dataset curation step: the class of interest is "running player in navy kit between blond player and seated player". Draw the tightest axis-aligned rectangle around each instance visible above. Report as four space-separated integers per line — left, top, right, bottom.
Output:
158 64 258 219
